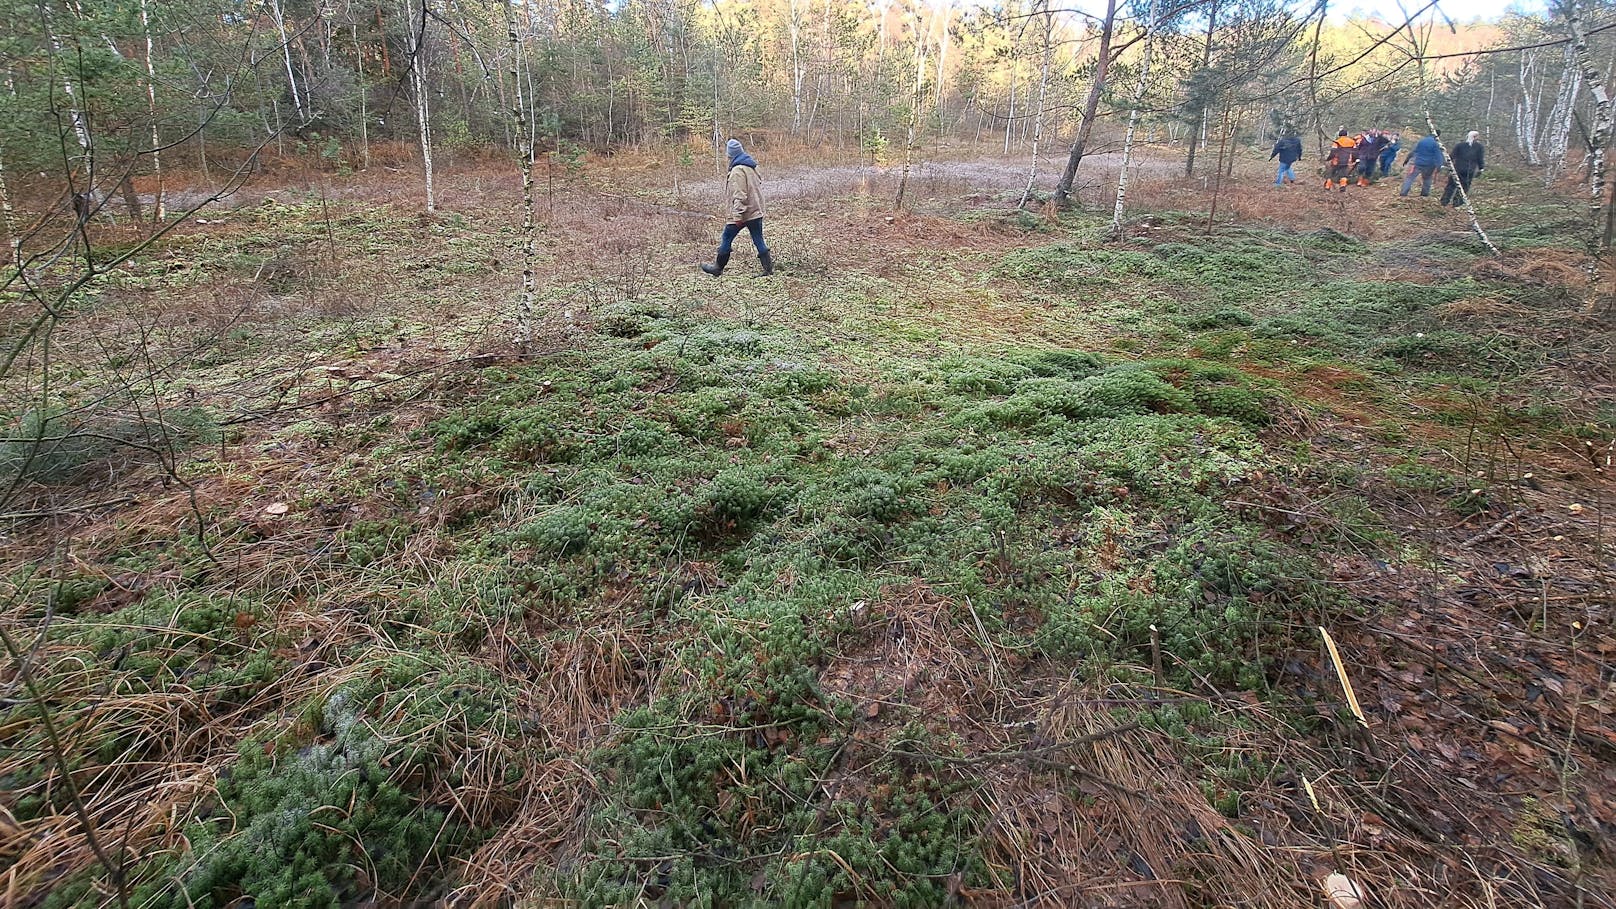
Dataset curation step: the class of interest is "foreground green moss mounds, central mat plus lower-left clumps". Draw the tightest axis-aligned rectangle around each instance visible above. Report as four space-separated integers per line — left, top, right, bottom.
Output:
10 279 1320 906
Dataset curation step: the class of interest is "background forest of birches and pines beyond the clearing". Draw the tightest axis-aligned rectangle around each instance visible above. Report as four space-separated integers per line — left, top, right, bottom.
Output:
0 0 1616 221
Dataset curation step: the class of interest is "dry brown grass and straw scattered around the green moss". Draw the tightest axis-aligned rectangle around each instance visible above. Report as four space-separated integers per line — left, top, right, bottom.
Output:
0 147 1608 909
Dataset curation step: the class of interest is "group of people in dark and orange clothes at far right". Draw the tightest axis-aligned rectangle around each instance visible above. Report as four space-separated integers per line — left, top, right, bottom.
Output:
1269 128 1487 205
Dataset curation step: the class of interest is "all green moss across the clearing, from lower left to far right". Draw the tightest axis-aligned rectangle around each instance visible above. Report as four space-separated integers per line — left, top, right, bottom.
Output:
15 187 1603 907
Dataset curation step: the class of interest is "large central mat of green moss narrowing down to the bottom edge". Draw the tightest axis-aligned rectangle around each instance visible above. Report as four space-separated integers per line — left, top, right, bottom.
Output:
400 299 1315 906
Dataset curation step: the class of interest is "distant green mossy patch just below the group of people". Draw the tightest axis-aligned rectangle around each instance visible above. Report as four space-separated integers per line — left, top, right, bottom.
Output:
994 219 1576 399
